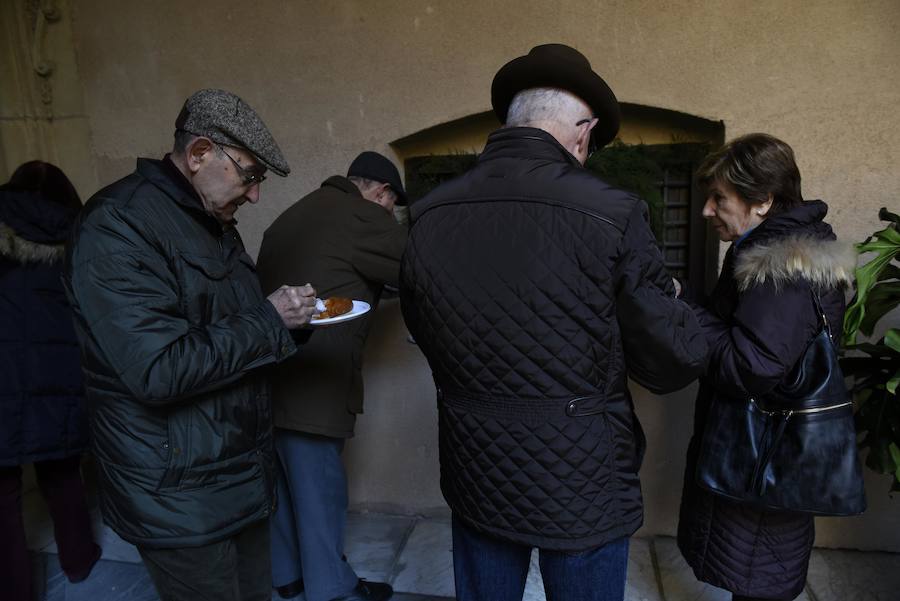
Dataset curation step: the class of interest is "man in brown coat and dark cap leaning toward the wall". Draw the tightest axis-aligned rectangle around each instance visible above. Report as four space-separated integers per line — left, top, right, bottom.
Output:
258 152 407 601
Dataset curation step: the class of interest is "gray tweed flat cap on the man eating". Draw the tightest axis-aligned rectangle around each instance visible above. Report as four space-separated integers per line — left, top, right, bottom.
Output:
175 89 291 177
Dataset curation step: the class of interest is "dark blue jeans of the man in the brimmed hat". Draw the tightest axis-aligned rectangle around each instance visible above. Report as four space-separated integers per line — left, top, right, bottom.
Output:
453 516 628 601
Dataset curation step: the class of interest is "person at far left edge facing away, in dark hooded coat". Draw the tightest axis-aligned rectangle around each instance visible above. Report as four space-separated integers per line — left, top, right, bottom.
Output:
0 161 101 601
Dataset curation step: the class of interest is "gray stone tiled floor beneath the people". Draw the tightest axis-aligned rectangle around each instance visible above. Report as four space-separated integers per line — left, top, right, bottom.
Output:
26 496 900 601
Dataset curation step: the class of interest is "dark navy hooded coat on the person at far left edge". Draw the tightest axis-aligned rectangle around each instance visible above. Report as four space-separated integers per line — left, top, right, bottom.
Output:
0 190 87 466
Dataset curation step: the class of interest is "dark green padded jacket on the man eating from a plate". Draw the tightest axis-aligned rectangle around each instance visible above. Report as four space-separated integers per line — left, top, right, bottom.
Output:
65 159 296 548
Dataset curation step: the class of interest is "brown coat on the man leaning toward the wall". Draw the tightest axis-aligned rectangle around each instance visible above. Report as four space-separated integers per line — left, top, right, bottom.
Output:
258 175 407 438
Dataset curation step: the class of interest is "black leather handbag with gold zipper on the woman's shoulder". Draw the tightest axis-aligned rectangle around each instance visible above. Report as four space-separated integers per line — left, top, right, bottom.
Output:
697 293 866 516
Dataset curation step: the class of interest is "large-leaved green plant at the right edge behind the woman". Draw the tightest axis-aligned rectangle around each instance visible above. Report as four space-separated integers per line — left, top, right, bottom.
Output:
841 208 900 492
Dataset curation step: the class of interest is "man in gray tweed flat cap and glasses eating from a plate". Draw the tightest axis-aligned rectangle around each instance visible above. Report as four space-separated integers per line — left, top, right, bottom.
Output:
65 90 315 601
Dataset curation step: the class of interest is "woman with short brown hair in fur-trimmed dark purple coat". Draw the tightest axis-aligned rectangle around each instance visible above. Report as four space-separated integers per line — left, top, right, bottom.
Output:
678 134 856 601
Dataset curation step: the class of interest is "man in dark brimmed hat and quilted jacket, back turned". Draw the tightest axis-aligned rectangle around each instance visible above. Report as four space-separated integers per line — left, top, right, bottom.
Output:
400 44 706 601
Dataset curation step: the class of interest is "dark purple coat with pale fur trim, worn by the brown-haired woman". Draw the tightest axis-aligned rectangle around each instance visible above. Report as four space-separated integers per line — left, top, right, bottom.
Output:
678 201 856 599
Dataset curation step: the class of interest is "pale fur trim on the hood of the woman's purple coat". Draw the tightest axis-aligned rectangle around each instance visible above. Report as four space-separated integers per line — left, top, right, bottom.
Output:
734 236 856 291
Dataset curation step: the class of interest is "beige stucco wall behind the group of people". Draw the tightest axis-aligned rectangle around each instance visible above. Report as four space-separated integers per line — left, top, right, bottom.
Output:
0 0 900 550
